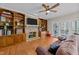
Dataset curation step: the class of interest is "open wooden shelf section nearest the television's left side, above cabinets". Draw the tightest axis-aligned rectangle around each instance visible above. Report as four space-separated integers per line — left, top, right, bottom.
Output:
13 12 25 34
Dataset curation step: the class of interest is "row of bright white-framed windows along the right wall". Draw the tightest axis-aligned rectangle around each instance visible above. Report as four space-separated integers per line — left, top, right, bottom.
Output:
53 20 79 36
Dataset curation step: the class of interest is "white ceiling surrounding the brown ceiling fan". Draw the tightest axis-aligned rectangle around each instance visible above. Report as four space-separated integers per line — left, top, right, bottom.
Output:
0 3 79 19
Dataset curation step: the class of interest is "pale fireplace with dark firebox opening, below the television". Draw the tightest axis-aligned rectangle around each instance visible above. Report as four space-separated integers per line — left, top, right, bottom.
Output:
26 25 39 40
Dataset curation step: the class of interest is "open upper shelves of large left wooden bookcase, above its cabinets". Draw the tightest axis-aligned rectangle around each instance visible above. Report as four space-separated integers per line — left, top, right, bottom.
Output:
0 8 25 36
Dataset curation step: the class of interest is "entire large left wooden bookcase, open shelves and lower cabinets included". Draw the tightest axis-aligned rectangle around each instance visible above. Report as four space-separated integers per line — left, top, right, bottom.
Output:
0 8 26 47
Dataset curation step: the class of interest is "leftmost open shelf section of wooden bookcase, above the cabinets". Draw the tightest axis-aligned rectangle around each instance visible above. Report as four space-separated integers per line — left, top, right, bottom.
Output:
0 8 13 36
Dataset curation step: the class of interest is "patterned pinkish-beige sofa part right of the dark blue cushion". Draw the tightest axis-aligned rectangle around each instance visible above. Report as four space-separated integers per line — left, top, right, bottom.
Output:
56 35 78 55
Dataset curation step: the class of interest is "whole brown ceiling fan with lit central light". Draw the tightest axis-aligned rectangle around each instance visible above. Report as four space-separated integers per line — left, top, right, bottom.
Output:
39 3 60 15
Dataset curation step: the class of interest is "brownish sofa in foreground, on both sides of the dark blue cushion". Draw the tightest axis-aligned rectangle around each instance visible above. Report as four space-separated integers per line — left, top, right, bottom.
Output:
36 35 79 55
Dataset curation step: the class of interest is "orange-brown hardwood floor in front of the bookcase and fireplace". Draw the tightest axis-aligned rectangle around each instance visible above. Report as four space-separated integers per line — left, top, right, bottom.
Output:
0 37 57 55
